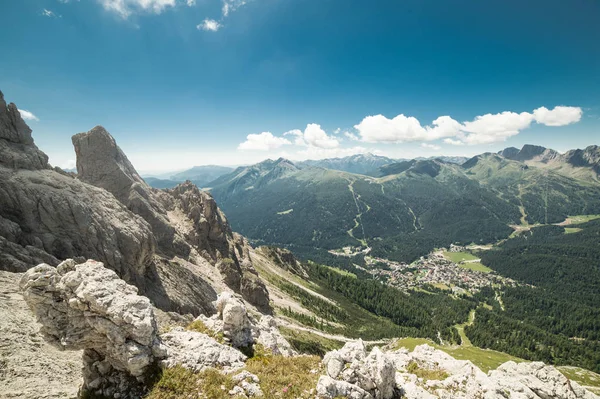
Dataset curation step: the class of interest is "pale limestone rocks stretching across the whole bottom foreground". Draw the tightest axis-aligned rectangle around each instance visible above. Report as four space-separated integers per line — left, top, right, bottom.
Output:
20 260 598 399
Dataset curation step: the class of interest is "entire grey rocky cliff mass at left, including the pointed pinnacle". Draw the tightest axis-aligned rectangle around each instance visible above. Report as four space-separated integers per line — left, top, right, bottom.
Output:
0 90 269 315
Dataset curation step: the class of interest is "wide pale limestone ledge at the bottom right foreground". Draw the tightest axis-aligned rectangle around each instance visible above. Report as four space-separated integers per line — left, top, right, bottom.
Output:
317 341 598 399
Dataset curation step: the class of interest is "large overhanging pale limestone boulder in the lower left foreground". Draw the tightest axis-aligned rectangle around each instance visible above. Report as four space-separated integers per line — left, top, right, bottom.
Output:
20 260 157 397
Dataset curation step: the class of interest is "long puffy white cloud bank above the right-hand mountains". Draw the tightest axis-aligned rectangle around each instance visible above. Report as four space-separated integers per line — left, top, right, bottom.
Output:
354 106 583 145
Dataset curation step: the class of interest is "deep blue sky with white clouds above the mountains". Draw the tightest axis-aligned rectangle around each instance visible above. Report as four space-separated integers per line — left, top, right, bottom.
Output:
0 0 600 171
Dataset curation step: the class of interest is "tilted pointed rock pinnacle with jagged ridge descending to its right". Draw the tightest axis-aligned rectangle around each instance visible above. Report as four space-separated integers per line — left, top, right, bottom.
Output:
72 126 269 311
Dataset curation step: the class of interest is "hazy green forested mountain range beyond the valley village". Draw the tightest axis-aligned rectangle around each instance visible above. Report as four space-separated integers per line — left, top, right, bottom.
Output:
208 145 600 261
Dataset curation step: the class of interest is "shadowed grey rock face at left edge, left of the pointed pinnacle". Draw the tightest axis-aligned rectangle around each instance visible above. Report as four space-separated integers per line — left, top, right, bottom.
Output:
0 93 155 285
